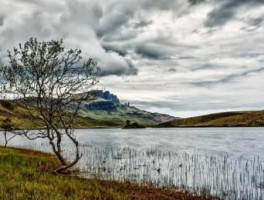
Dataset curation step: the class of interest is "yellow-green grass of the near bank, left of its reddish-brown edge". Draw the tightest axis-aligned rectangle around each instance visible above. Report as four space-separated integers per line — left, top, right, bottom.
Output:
0 148 129 200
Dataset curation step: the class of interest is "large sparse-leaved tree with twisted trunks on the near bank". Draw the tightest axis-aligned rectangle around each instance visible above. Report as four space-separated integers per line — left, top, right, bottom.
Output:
2 38 99 172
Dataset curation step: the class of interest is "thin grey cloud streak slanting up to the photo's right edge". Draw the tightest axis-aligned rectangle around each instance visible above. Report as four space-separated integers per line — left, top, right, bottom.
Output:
191 66 264 87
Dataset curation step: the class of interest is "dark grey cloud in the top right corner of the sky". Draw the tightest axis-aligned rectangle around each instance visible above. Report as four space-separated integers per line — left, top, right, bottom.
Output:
205 0 264 27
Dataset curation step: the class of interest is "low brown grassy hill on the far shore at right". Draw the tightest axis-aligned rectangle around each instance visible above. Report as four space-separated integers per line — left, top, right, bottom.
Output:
158 111 264 127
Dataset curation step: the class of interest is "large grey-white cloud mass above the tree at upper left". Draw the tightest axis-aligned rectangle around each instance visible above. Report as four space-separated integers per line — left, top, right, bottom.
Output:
0 0 140 76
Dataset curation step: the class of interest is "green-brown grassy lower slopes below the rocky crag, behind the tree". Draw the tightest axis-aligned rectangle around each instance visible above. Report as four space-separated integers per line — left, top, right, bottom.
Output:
0 100 163 129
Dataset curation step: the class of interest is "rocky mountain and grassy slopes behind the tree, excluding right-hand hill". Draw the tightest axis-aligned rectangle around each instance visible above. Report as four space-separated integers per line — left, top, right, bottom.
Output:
0 90 174 129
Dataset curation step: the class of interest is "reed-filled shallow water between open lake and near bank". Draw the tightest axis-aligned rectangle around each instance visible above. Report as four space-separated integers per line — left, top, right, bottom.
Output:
11 143 264 200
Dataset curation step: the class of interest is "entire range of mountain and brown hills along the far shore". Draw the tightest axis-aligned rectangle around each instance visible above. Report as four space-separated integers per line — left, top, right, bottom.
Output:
0 96 264 129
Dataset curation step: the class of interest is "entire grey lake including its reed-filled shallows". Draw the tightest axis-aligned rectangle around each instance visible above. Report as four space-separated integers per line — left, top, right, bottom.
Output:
0 128 264 199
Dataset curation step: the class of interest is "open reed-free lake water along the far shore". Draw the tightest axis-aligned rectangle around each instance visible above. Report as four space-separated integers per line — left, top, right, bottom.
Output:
3 128 264 161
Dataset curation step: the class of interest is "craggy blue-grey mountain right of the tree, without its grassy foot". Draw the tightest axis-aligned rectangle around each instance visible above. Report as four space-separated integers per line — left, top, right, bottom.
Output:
74 90 175 126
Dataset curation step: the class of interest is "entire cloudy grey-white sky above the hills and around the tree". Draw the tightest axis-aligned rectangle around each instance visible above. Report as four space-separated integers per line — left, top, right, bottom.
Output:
0 0 264 117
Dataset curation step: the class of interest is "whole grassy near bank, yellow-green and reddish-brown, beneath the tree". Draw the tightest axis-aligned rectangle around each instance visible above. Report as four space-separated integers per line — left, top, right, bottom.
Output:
0 147 213 200
